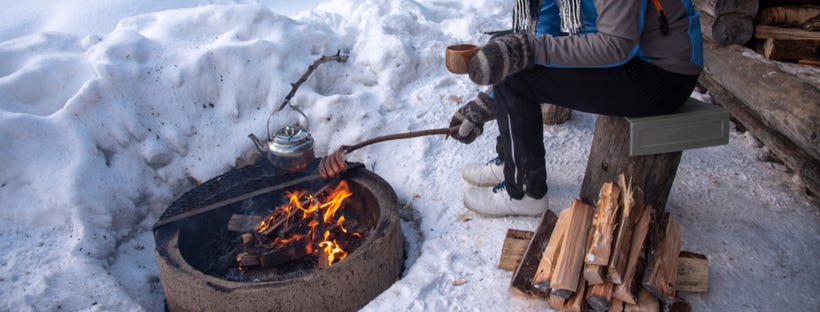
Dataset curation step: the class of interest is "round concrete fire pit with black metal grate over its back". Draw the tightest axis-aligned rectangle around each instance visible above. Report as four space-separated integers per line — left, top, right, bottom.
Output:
154 160 404 311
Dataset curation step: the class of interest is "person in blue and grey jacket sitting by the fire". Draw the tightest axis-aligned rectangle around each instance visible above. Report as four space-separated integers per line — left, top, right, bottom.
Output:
450 0 703 216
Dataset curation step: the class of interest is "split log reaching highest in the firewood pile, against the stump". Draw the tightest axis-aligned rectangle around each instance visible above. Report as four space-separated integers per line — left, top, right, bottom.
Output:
607 175 644 284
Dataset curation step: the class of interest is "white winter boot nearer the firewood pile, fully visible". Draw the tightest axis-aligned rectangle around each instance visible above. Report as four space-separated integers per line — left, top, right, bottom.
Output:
464 182 549 217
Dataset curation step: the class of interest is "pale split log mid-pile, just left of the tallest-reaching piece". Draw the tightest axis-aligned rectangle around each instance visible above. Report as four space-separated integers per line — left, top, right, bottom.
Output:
584 182 621 266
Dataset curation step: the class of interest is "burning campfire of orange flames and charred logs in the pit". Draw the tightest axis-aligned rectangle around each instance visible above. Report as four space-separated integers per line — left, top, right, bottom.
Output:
237 180 363 270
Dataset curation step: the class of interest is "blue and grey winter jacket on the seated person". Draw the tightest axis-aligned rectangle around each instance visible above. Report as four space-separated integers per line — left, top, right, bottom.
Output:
536 0 703 75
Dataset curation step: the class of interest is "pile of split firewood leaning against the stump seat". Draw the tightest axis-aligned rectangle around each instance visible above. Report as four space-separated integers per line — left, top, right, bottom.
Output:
501 175 708 311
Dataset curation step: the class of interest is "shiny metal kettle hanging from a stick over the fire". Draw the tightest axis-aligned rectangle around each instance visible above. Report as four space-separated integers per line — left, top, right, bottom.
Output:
248 126 314 171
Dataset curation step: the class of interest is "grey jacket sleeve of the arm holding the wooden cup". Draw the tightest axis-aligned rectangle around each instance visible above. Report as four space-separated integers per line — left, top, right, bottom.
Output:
535 0 646 67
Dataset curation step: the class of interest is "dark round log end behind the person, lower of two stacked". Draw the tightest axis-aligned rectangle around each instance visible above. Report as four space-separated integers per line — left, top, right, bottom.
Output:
700 12 755 46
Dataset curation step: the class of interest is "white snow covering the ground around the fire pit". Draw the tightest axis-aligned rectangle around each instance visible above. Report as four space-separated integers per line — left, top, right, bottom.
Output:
0 0 820 311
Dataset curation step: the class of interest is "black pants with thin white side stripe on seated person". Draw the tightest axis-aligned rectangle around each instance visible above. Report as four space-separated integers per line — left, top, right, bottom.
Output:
493 59 698 199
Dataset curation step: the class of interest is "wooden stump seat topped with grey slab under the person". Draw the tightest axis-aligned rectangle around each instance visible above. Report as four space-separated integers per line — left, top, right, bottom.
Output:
580 98 730 220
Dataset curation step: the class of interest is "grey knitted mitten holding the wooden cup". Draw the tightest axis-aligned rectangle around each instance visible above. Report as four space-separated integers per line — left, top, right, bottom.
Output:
467 32 536 85
